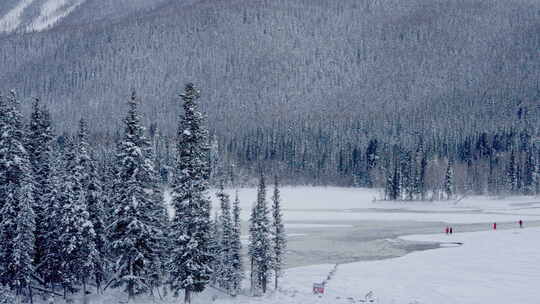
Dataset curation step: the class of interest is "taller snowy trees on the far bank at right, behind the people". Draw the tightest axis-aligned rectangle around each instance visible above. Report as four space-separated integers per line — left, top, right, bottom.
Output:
382 120 540 200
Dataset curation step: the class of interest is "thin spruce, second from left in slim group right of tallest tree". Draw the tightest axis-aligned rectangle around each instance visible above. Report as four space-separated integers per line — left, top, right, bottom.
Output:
230 191 244 296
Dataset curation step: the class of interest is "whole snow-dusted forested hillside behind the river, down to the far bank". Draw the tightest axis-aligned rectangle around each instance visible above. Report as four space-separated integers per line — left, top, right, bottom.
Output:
0 0 540 190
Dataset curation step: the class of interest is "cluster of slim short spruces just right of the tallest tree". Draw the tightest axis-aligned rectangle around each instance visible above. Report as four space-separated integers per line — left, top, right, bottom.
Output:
212 175 287 295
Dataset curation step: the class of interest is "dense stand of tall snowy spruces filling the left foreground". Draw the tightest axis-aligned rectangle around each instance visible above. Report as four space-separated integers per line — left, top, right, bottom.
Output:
0 84 285 302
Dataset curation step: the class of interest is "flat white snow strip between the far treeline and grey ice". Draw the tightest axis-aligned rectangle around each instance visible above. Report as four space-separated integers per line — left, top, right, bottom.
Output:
204 185 540 224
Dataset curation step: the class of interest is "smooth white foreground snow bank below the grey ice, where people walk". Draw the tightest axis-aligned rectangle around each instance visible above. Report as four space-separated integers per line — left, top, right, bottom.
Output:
55 227 540 304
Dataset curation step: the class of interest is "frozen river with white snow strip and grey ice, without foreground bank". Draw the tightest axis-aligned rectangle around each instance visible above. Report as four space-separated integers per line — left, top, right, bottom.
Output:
213 187 540 268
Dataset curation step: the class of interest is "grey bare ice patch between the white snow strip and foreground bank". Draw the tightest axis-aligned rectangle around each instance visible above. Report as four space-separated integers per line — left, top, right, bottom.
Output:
287 215 540 268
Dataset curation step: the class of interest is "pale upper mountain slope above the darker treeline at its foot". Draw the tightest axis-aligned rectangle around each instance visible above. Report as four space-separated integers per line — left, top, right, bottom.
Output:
0 0 540 140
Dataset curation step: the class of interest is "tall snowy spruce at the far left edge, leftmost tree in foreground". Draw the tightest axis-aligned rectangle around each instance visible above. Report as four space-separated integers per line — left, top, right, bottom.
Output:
0 92 35 294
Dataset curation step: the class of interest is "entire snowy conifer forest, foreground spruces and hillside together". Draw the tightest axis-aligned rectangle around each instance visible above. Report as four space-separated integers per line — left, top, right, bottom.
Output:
0 0 540 303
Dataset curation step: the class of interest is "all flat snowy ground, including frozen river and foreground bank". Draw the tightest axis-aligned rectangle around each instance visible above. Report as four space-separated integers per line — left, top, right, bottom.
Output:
42 187 540 304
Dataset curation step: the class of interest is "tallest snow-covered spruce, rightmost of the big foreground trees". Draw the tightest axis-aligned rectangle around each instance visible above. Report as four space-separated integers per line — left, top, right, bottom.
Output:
169 83 212 303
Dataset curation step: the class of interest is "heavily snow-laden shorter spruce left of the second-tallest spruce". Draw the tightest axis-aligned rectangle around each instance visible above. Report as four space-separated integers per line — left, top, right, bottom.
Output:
59 138 99 292
